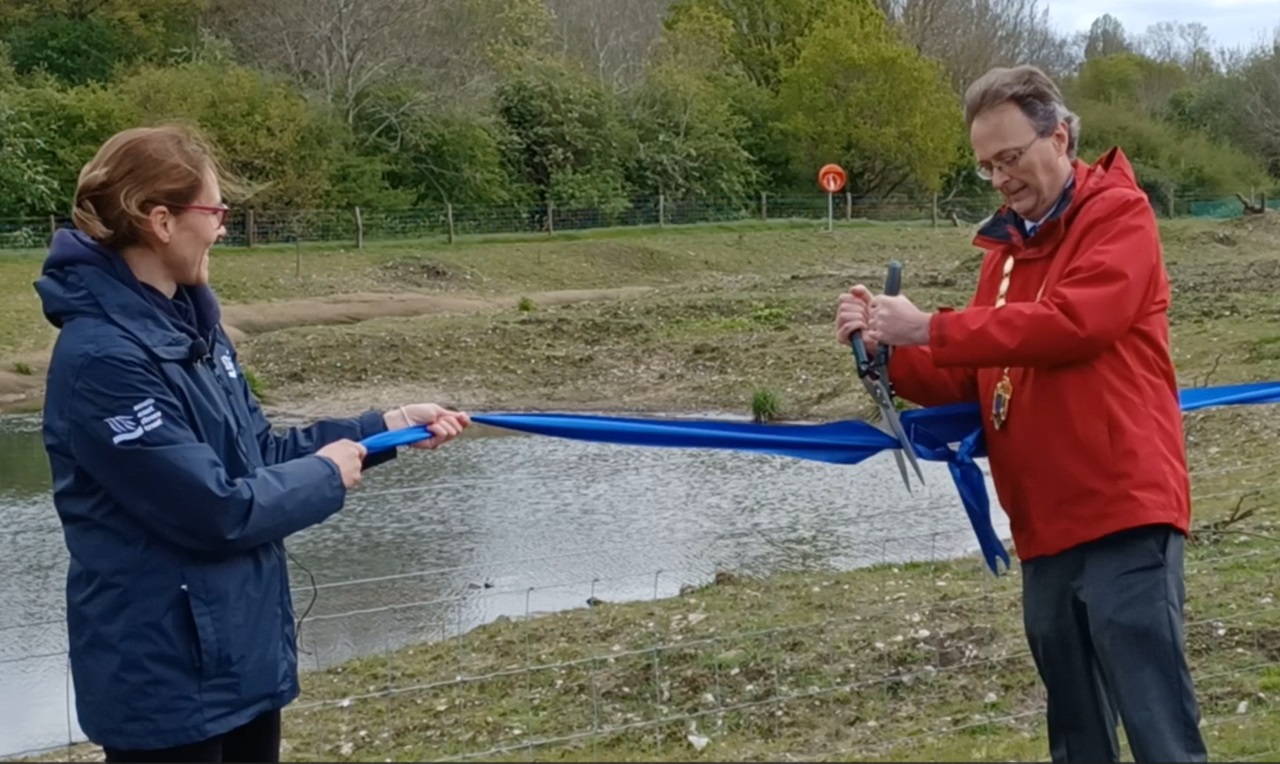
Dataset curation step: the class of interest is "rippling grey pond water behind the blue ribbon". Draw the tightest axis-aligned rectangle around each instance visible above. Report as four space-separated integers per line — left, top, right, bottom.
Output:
0 406 1007 755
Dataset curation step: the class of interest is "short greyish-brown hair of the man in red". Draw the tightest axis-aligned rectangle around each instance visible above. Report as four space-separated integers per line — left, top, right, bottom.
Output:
964 65 1080 159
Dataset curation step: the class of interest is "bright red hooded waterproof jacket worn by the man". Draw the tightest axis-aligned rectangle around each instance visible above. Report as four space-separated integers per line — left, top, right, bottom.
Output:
890 148 1190 561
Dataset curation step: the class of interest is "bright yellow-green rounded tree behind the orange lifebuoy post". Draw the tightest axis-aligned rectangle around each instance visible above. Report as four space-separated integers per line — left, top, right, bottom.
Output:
780 0 963 196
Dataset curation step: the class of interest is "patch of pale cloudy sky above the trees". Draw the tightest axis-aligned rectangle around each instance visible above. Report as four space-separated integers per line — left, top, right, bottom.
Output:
1041 0 1280 50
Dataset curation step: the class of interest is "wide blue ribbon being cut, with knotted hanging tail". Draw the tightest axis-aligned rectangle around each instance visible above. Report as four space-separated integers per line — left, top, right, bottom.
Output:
361 381 1280 575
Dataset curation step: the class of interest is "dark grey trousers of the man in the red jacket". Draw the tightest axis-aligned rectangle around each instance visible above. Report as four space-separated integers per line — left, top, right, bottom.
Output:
1023 525 1207 761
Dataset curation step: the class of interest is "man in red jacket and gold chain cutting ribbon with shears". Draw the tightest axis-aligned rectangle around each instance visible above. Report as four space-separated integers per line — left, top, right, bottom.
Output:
836 67 1206 761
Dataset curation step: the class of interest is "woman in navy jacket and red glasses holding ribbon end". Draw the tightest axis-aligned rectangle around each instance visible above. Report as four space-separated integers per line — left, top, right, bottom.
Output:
36 127 470 761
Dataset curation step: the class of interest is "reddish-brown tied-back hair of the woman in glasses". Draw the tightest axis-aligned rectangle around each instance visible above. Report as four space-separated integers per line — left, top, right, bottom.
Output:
72 125 229 250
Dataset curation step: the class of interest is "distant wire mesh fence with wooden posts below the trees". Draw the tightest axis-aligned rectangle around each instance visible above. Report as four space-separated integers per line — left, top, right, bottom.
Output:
0 192 1264 250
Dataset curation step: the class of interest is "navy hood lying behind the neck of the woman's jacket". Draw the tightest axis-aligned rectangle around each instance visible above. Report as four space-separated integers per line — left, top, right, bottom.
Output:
35 228 221 360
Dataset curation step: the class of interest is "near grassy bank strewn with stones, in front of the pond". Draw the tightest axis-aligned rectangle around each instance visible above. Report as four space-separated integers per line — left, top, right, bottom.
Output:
275 524 1280 761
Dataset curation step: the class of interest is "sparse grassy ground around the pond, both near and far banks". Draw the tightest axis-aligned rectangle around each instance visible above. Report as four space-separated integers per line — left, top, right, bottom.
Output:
0 218 1280 760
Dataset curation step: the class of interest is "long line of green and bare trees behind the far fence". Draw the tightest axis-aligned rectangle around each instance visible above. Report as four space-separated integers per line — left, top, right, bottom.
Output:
0 0 1280 218
